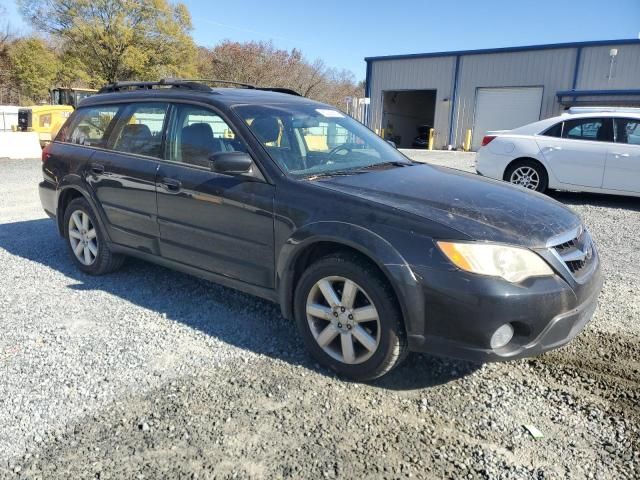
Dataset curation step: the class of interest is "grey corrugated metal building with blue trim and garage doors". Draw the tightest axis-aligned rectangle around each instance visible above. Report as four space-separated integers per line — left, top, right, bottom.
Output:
365 39 640 149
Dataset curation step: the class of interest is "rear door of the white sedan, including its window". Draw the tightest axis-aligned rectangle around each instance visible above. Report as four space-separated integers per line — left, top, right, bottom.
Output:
536 118 613 188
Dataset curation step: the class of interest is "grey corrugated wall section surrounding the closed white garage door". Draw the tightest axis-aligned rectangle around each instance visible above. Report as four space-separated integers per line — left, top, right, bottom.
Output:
452 48 576 146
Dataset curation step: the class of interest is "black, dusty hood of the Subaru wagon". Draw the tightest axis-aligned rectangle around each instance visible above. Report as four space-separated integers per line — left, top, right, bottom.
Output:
316 165 581 248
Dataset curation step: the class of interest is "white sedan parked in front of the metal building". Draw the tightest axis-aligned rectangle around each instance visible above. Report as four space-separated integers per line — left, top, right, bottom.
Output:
476 109 640 196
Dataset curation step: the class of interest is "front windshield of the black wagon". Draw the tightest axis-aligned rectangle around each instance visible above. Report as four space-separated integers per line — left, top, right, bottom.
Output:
235 104 410 177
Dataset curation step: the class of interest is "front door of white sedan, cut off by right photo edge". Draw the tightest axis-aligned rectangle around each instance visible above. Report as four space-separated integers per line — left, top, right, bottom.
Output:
602 118 640 193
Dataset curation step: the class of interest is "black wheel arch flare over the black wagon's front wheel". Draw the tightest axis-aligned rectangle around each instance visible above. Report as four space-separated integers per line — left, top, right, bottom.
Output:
276 221 425 333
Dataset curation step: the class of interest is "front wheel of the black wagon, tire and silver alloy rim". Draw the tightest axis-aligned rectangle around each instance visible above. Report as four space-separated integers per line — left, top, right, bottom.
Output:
294 254 407 381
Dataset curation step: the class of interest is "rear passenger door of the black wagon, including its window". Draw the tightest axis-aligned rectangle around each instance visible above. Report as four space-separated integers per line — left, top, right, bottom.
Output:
86 102 169 254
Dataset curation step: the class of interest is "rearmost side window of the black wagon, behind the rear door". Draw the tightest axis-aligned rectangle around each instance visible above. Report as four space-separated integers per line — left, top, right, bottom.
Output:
56 105 120 148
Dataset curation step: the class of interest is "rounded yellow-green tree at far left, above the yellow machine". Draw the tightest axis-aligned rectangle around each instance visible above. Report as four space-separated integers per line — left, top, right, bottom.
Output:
9 37 58 102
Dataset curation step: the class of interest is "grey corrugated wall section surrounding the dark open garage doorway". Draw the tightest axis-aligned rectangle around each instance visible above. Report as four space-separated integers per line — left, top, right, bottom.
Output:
369 57 456 148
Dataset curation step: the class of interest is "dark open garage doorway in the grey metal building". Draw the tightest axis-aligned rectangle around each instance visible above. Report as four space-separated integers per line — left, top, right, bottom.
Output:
382 90 436 148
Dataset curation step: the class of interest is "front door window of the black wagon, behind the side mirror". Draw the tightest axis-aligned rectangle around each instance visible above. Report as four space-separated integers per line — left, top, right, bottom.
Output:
168 104 247 168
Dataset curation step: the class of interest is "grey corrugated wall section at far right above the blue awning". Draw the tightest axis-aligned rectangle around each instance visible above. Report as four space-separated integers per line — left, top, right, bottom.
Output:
576 45 640 90
